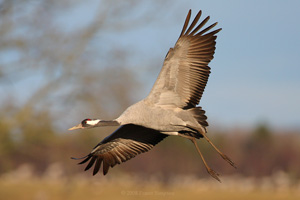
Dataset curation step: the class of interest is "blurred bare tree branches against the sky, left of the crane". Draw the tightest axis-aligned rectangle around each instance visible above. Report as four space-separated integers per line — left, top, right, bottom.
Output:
0 0 170 130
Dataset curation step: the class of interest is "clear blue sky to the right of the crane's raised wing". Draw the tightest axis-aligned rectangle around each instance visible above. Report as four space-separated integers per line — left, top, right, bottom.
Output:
190 1 300 128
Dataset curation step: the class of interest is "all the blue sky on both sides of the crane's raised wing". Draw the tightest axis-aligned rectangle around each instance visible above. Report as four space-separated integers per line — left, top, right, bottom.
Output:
0 0 300 129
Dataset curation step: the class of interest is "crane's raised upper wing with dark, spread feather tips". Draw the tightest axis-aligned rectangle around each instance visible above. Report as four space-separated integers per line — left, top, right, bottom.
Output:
146 10 221 108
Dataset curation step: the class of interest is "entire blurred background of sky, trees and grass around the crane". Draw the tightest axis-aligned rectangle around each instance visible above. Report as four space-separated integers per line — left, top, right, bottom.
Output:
0 0 300 199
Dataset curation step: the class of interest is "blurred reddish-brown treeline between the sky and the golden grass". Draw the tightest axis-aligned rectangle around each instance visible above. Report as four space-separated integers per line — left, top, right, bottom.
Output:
0 113 300 178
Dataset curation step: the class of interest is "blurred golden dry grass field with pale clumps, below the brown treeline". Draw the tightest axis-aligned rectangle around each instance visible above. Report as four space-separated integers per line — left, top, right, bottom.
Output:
0 166 300 200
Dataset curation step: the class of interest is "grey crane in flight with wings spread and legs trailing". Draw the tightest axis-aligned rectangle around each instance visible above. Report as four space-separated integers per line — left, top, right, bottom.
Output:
69 10 236 181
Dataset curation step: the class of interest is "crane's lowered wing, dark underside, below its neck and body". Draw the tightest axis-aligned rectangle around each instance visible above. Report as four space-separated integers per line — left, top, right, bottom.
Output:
75 124 167 175
